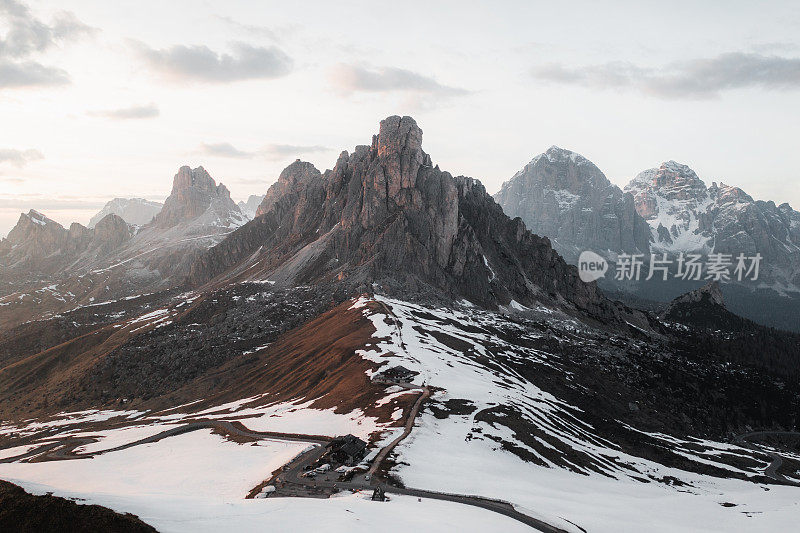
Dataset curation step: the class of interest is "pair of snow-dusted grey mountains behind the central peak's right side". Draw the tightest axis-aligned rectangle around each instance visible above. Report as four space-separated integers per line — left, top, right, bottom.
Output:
495 146 800 331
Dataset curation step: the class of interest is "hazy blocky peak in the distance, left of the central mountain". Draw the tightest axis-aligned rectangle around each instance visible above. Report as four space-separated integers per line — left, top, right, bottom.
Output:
152 166 245 228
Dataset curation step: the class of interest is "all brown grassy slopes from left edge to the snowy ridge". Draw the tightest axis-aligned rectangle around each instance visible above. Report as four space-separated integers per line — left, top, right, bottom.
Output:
0 299 413 422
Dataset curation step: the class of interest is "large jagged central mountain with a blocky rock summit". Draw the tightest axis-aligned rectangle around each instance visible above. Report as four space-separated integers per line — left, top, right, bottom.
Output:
191 116 618 320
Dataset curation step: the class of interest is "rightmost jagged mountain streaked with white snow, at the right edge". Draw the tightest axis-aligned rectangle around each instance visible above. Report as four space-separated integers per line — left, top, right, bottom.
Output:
625 161 800 290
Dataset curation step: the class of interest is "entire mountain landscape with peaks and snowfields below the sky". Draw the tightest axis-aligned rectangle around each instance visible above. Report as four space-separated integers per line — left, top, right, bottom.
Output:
0 116 800 533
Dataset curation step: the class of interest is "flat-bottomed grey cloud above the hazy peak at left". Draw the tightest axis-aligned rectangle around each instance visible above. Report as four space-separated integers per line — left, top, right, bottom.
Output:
134 43 294 83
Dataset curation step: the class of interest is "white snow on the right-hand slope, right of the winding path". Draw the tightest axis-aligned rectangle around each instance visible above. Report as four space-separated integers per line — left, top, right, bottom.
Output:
358 297 800 531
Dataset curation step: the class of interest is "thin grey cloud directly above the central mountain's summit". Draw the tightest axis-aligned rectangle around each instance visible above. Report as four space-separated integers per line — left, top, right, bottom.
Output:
328 63 469 97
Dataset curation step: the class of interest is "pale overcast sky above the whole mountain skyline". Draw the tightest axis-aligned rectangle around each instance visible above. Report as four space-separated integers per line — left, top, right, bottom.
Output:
0 0 800 235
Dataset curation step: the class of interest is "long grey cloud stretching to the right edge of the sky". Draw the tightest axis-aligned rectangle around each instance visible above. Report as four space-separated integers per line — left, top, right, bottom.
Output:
531 52 800 99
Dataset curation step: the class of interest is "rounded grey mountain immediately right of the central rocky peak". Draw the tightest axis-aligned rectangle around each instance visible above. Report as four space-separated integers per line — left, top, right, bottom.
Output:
495 146 650 260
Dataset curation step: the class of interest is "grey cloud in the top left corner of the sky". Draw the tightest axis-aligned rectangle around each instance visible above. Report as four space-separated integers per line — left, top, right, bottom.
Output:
0 0 97 89
